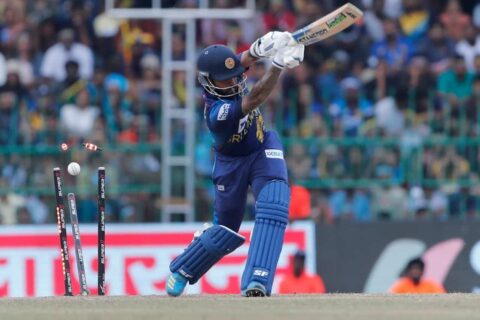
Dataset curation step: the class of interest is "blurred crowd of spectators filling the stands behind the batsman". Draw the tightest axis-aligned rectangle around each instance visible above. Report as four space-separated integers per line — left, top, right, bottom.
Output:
0 0 480 224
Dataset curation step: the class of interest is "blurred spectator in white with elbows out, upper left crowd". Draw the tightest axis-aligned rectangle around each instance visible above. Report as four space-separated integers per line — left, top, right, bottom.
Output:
40 29 94 81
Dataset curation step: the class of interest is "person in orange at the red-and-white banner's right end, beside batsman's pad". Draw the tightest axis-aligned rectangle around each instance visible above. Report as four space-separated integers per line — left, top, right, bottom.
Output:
278 250 326 294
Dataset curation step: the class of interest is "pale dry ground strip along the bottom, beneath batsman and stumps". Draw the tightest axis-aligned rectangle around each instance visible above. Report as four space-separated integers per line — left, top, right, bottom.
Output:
0 294 480 320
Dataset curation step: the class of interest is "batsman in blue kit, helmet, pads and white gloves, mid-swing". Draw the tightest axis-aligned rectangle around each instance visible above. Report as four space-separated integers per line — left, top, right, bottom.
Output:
167 31 304 297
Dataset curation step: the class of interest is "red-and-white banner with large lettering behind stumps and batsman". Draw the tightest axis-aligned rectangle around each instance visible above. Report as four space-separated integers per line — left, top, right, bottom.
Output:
0 222 316 297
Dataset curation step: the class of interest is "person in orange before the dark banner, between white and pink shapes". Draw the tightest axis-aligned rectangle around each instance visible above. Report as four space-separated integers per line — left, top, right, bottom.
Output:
390 258 445 294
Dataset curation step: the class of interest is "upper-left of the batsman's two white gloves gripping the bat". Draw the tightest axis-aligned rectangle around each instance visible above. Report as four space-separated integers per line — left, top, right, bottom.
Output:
249 31 293 59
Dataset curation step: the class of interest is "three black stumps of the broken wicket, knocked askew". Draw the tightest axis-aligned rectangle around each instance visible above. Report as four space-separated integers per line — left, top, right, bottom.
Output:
53 167 105 296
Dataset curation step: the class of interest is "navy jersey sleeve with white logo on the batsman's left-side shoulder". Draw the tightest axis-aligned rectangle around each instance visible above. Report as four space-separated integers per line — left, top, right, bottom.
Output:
209 100 243 132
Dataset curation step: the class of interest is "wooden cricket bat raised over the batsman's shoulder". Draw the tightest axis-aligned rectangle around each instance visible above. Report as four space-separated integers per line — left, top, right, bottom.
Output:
289 3 363 46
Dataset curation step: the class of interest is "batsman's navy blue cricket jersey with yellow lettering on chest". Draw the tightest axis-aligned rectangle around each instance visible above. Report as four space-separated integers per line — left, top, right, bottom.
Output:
203 92 267 156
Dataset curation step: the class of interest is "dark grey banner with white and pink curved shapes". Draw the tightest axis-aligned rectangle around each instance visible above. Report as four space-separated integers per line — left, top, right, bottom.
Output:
317 221 480 293
